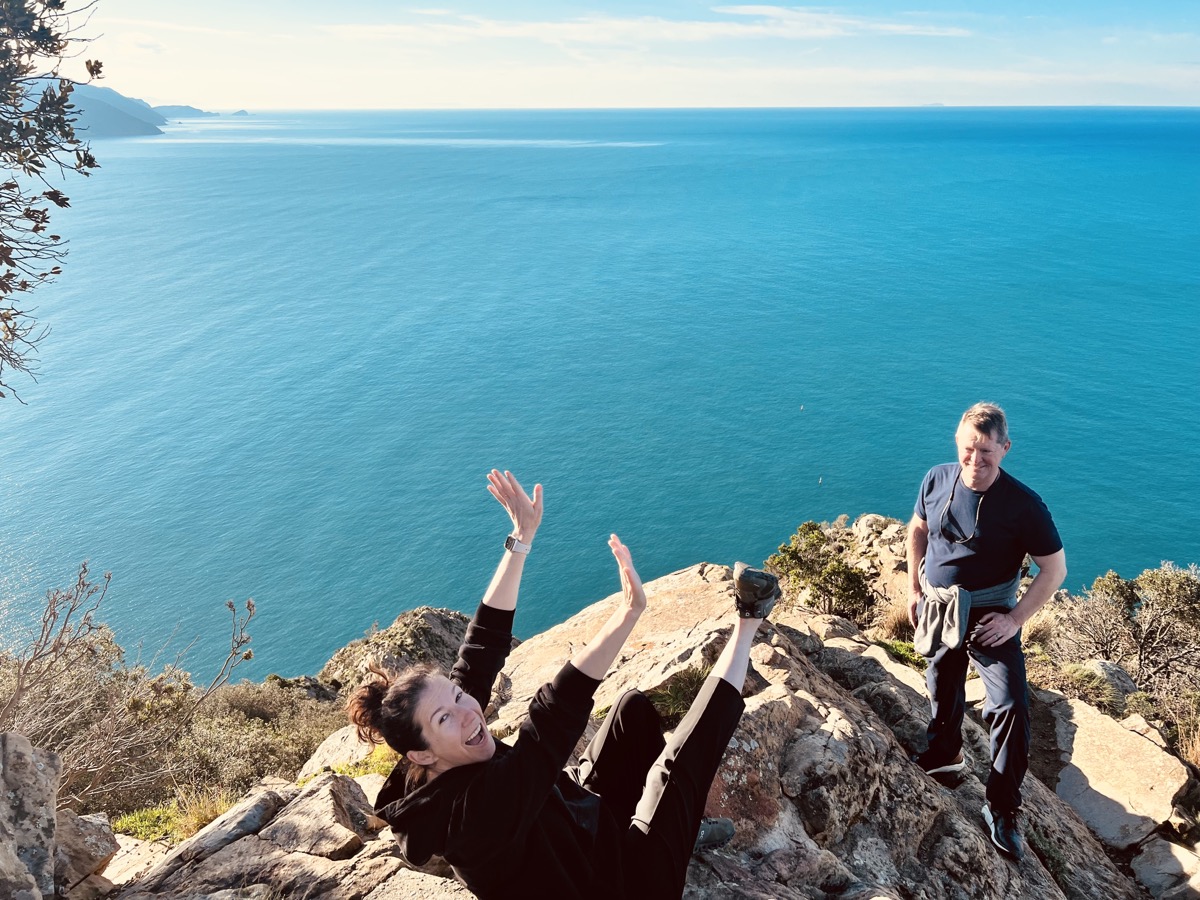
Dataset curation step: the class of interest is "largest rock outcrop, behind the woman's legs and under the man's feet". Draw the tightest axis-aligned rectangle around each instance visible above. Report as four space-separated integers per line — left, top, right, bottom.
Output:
458 564 1138 900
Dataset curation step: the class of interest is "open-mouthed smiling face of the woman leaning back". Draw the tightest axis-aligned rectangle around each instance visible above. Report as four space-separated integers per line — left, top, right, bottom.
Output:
408 676 496 778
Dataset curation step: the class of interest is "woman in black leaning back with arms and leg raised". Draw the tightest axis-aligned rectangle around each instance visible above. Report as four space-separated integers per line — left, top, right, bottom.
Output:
348 469 779 900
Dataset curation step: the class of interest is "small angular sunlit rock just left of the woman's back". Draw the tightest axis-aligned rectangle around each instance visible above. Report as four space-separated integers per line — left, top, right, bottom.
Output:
258 773 373 859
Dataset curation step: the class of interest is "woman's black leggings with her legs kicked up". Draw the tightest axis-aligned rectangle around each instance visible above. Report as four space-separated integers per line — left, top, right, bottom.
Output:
578 677 745 900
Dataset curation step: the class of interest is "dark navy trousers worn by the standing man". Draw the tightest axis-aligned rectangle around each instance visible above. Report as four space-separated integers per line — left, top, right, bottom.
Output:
925 606 1030 812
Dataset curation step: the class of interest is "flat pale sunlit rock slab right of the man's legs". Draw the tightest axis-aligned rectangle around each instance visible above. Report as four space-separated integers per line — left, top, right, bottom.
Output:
1038 691 1189 850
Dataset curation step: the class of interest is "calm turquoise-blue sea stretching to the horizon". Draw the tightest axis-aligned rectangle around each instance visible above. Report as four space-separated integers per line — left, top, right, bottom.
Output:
0 108 1200 678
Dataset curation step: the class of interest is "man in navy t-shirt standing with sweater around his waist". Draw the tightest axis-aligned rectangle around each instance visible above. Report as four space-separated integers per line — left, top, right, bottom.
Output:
908 403 1067 860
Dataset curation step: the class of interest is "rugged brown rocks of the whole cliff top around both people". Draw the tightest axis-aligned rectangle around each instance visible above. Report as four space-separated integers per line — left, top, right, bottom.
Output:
0 520 1200 900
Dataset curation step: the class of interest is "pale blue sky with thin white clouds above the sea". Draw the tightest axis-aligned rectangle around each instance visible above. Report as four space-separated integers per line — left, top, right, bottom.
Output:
77 0 1200 110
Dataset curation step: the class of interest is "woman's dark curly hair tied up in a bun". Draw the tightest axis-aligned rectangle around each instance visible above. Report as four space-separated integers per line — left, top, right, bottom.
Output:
346 662 444 787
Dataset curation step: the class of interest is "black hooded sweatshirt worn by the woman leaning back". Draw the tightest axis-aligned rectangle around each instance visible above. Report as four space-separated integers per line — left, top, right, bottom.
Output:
376 605 625 900
